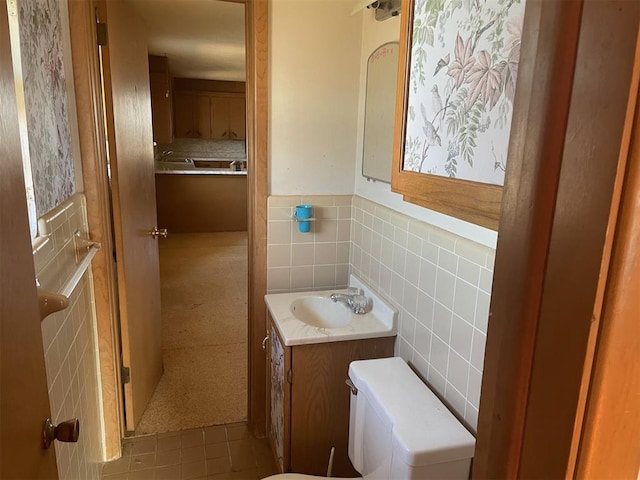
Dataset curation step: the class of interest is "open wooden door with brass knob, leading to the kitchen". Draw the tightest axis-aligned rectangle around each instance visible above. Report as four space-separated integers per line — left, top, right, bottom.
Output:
99 0 163 430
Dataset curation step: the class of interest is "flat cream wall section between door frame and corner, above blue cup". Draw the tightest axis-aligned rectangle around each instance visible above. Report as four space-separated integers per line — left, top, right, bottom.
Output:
269 0 362 195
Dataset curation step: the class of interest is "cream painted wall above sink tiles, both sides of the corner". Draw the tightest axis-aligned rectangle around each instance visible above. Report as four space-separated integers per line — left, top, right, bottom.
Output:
269 0 497 248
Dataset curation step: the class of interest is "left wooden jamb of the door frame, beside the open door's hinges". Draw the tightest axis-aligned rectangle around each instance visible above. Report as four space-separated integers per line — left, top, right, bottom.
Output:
69 1 124 460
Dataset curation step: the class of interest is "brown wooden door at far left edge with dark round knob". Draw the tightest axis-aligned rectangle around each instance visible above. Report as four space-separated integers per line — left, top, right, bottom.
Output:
0 2 58 479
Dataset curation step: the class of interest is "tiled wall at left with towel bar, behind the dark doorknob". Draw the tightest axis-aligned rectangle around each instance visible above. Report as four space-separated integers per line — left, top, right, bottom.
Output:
33 194 103 480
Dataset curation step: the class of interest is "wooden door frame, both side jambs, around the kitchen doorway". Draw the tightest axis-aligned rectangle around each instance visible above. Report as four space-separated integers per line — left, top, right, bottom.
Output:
69 0 269 459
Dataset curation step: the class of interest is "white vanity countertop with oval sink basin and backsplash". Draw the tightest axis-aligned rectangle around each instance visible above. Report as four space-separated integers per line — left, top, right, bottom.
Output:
265 275 398 346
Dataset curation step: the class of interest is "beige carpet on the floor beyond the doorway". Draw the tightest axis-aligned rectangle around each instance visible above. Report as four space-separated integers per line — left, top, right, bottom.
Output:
136 232 247 435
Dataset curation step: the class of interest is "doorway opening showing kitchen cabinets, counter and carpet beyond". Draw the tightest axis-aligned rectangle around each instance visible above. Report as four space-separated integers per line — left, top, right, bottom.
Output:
129 0 248 435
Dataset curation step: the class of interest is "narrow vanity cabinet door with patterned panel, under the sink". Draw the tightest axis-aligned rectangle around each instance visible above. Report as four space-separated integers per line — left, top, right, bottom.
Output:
268 323 291 472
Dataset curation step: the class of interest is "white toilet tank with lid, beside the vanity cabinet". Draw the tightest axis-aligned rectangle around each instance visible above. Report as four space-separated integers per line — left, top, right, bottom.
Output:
349 357 475 480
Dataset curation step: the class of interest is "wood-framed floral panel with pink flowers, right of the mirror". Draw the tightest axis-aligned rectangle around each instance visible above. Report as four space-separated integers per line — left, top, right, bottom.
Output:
391 0 524 229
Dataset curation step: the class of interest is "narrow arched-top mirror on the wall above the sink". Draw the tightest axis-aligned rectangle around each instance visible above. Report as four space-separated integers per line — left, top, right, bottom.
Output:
362 42 399 183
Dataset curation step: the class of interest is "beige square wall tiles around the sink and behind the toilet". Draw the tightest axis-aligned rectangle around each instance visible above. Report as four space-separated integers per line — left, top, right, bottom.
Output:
267 195 495 432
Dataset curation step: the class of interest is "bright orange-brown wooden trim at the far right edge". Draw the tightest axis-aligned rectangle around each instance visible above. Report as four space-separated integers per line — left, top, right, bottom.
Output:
574 32 640 479
